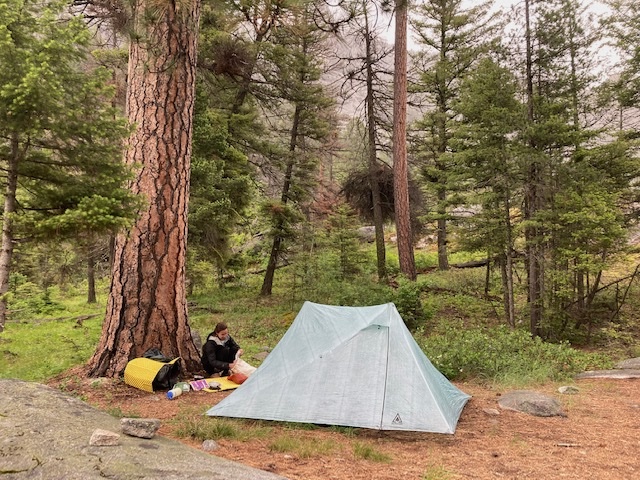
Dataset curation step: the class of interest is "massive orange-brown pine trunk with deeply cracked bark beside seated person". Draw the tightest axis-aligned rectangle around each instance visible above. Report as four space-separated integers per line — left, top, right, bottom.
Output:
88 0 201 376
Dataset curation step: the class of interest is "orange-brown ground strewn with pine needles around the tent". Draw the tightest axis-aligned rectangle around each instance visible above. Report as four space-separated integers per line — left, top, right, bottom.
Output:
50 376 640 480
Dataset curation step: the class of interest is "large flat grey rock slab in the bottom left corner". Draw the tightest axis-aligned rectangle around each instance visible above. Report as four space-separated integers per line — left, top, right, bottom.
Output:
0 379 284 480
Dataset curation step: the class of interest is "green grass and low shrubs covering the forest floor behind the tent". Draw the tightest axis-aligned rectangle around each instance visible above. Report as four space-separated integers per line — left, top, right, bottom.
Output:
0 244 638 385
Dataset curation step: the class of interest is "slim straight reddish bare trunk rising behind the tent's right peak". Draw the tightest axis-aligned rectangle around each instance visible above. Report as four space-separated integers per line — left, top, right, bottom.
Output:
393 0 416 280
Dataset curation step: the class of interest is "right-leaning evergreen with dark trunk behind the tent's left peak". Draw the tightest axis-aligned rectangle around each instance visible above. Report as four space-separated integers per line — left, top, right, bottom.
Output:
260 3 334 295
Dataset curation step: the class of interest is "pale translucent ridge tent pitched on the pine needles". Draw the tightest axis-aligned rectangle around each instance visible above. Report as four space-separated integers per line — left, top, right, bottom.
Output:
207 302 470 433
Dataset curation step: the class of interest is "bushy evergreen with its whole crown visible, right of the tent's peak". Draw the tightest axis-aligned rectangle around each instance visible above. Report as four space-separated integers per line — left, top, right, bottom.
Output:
452 59 524 327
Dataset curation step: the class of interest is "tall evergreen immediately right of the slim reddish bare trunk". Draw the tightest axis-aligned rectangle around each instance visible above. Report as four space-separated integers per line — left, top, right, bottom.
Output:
414 0 496 270
